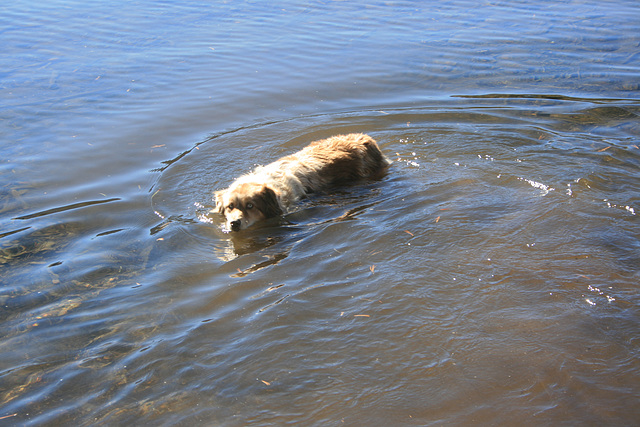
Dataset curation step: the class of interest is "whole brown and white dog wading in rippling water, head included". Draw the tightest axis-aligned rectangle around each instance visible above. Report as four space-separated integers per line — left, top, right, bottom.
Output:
214 133 390 231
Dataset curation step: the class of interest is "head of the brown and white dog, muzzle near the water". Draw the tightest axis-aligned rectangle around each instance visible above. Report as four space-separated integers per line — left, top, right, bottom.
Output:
215 183 282 231
